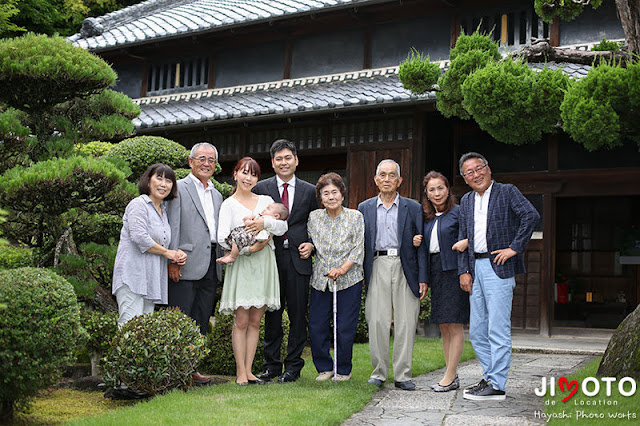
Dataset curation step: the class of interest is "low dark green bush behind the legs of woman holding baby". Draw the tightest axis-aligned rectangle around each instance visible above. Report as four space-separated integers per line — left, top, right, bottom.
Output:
201 304 289 376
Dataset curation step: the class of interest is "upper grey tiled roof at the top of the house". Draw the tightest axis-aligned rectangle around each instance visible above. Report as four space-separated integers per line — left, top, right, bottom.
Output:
68 0 391 51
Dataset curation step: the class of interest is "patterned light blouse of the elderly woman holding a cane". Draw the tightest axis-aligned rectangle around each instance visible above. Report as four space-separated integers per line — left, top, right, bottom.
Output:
307 208 364 291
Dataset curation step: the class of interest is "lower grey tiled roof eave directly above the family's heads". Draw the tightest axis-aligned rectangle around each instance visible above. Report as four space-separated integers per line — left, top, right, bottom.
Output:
133 62 590 130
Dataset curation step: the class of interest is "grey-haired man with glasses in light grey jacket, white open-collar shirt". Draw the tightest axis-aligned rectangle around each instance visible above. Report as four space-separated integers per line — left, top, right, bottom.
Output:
167 142 222 384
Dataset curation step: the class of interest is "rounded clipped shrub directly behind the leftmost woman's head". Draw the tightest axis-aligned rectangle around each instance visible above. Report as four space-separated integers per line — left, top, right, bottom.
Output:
107 136 189 181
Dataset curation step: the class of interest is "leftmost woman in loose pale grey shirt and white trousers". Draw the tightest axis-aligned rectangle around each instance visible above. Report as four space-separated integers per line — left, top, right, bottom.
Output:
112 163 187 327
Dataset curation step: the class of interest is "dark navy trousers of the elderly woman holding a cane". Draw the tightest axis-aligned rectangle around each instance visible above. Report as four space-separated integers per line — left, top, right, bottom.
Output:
309 281 362 376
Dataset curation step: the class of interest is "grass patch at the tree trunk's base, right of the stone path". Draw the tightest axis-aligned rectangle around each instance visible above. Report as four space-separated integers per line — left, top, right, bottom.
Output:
545 358 640 426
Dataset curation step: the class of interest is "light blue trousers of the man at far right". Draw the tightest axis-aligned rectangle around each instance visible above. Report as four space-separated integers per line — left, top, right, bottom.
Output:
469 259 516 391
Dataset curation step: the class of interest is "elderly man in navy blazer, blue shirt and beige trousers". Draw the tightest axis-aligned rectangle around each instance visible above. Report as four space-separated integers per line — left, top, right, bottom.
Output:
358 160 427 390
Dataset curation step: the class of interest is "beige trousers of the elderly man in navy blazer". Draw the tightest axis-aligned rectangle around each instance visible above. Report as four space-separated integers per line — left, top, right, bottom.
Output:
365 256 420 382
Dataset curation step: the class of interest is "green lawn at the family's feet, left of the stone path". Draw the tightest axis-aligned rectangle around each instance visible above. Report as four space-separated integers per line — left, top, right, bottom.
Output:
13 337 474 425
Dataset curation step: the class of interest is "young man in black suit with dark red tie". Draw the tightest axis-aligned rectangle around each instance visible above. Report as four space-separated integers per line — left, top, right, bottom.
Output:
247 139 318 383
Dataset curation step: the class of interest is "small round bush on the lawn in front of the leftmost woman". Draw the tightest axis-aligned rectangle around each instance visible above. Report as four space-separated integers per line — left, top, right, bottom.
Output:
102 308 209 395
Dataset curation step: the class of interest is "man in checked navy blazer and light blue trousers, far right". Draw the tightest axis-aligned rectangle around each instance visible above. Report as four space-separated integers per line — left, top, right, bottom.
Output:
458 152 540 400
